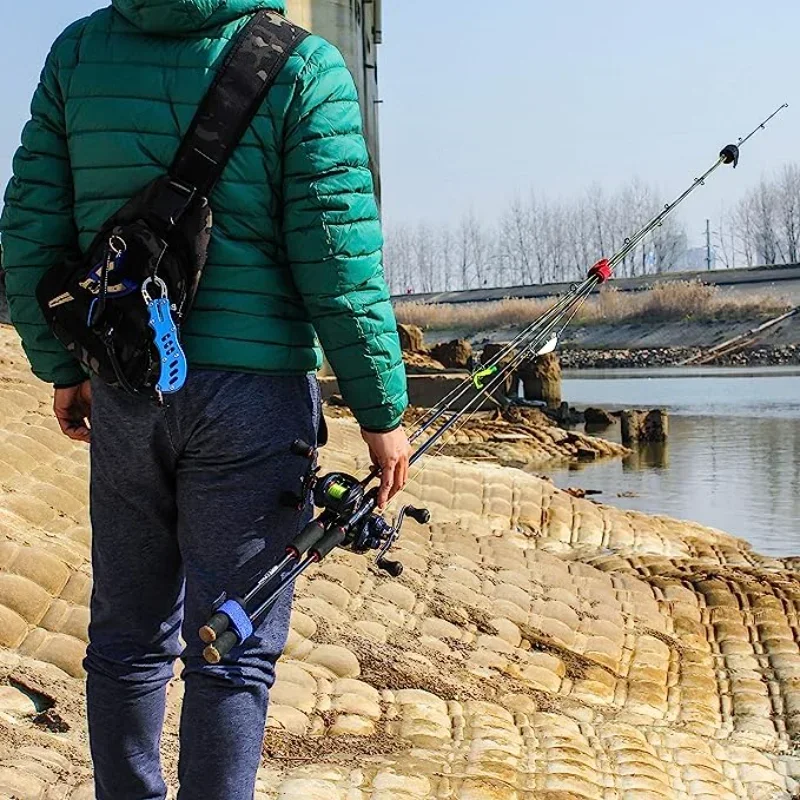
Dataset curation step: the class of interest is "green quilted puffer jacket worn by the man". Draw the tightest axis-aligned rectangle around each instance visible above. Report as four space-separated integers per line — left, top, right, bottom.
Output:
0 0 407 430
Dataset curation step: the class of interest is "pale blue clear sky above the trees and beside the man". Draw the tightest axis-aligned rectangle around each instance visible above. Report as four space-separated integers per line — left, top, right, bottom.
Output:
0 0 800 252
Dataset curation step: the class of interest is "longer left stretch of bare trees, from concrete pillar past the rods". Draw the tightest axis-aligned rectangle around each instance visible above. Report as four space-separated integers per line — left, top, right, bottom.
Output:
386 181 692 291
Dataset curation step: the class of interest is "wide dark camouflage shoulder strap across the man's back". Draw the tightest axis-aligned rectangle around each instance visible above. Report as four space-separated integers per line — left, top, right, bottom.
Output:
170 10 309 197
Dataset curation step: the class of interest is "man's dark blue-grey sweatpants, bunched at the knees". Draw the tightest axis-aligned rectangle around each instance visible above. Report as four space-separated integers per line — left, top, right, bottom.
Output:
85 371 320 800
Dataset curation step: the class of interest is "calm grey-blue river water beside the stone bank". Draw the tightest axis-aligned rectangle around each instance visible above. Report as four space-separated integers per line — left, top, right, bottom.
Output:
548 367 800 556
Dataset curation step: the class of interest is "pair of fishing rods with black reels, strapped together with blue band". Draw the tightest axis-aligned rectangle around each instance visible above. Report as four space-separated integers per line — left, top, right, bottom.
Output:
199 103 788 664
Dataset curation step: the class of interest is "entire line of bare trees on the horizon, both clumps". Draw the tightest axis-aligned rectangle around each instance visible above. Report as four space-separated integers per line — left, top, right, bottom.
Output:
385 164 800 294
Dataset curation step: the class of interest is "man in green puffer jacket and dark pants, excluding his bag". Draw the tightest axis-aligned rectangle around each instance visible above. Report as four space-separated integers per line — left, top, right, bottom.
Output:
0 0 410 800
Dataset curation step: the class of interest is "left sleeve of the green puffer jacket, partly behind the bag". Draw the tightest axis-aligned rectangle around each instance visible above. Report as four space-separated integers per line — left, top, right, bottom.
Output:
0 42 84 385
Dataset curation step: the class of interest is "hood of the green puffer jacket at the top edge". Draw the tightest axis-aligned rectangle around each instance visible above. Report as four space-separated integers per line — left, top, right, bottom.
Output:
112 0 286 35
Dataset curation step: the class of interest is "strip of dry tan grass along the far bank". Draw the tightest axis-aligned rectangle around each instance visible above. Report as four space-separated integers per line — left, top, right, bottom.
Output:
395 281 791 332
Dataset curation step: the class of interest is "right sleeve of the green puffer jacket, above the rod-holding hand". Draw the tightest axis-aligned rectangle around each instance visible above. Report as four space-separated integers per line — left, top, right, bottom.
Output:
283 37 408 431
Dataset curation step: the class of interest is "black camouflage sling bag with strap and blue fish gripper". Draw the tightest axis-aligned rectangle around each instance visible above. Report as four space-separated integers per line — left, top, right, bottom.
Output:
37 10 308 399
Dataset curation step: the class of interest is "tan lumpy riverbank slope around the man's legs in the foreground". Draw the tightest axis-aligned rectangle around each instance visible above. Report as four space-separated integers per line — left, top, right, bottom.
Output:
0 329 800 800
